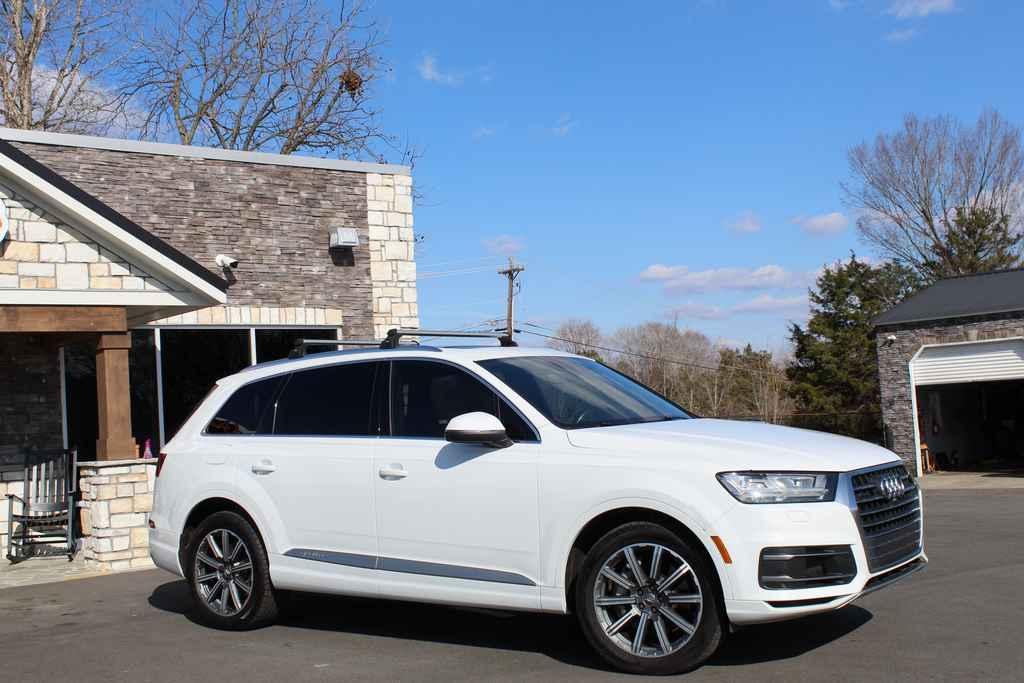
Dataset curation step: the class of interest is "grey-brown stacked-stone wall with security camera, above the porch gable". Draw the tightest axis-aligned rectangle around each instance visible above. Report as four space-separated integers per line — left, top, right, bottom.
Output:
13 142 385 336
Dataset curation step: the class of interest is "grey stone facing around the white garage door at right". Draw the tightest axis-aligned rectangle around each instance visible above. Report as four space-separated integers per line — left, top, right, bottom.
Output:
874 312 1024 472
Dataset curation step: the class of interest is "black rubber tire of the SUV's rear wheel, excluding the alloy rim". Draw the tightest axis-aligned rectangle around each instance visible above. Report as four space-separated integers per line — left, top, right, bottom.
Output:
185 511 278 631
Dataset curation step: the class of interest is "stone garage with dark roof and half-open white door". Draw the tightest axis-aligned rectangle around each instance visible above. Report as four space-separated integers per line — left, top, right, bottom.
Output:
874 269 1024 474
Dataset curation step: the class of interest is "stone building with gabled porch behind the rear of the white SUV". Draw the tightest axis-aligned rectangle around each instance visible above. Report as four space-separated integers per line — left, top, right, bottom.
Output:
0 129 419 565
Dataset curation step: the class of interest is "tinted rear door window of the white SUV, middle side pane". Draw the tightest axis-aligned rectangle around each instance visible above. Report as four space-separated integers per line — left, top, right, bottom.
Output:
273 362 380 436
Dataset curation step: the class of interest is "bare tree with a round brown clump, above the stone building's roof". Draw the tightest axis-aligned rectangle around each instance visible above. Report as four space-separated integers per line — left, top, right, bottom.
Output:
130 0 409 157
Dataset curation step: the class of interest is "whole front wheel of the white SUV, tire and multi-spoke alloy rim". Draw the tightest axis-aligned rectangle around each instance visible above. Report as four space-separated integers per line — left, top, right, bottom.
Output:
575 522 722 674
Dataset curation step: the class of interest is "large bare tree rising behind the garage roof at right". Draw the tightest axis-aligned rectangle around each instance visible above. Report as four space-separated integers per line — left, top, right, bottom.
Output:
843 111 1024 280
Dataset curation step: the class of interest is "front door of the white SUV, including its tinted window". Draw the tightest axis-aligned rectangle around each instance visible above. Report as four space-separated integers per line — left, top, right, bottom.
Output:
374 359 540 607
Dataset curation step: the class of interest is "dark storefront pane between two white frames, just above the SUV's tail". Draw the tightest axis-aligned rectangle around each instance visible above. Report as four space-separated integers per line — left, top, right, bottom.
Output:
160 328 250 440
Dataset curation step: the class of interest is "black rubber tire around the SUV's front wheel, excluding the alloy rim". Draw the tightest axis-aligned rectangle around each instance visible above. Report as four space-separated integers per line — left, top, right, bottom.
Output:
575 522 723 675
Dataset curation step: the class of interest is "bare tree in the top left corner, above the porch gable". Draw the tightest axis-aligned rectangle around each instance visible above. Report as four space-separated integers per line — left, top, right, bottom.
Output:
0 0 132 134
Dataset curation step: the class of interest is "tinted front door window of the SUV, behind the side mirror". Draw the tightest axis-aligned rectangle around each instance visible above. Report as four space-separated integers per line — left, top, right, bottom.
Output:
391 360 536 441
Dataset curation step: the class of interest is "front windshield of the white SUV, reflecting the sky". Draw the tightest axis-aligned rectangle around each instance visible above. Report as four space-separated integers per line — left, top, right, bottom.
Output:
477 356 691 429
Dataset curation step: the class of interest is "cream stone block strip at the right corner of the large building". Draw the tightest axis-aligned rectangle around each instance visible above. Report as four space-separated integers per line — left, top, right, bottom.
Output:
367 173 420 339
